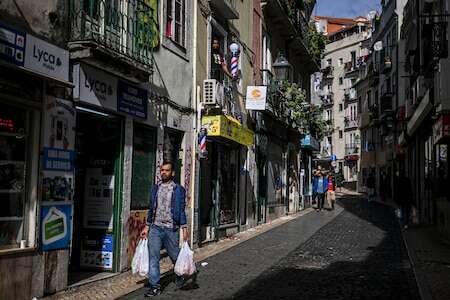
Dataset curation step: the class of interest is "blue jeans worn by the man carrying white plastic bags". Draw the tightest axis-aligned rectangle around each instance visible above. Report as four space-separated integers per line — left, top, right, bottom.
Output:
148 225 180 288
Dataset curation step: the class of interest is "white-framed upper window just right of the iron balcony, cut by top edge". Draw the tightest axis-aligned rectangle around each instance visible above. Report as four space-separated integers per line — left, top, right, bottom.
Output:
165 0 186 47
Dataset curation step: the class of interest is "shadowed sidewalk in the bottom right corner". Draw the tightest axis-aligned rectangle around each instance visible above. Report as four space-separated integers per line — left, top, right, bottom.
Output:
403 227 450 300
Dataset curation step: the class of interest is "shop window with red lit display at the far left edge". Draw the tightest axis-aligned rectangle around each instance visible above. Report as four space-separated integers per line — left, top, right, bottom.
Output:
0 104 29 250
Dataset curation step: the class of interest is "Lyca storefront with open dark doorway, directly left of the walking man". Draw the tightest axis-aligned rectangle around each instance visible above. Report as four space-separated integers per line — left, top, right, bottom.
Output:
69 64 148 284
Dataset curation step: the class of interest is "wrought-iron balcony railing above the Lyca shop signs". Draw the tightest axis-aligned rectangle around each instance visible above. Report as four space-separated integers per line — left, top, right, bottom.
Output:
70 0 159 65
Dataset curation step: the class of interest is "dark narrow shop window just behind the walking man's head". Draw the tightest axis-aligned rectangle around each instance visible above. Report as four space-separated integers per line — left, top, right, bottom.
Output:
131 124 156 210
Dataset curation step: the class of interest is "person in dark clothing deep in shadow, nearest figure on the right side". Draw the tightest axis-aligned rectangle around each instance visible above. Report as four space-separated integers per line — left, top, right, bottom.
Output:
394 171 413 229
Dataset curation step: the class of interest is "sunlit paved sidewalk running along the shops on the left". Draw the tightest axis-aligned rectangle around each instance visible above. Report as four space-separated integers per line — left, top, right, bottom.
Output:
42 208 313 300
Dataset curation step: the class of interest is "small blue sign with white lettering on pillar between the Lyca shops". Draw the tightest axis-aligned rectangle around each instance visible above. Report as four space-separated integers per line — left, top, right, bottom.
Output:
42 147 75 171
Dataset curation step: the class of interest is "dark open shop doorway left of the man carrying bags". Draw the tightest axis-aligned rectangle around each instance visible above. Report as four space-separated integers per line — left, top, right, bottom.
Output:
69 111 123 283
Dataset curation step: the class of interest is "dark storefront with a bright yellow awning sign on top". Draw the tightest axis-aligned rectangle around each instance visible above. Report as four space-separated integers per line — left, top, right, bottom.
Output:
198 115 254 244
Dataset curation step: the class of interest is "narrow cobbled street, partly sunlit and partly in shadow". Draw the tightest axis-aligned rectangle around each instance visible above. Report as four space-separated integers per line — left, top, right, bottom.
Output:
122 196 419 300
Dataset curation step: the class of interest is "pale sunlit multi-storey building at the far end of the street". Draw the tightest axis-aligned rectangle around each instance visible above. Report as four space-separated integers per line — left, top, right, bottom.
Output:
316 17 370 189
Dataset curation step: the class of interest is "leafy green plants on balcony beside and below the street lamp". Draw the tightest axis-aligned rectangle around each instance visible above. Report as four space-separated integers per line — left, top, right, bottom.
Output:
280 83 326 139
